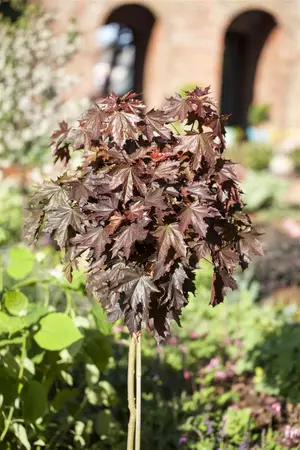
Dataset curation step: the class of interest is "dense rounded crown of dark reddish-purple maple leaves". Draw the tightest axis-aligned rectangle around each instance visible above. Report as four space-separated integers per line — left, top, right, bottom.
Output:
26 88 261 340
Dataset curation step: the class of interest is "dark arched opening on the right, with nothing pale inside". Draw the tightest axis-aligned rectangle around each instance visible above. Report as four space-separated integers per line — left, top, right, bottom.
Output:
221 10 276 128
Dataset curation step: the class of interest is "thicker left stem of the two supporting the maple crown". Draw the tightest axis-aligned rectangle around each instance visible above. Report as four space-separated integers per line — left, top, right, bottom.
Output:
127 336 136 450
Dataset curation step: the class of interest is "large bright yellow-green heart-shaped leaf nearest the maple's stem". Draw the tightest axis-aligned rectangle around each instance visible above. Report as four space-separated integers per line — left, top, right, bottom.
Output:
34 313 83 351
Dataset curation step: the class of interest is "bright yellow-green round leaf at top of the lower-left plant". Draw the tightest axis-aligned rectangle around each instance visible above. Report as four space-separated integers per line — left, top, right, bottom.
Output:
7 247 34 280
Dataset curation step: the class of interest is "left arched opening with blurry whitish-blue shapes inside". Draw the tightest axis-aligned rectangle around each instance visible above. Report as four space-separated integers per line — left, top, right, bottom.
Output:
95 4 155 95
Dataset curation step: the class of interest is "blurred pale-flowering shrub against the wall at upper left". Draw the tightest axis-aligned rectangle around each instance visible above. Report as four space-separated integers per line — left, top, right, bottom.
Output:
0 5 85 167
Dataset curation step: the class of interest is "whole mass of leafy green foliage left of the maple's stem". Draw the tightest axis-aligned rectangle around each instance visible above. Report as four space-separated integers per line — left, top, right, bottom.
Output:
0 246 122 450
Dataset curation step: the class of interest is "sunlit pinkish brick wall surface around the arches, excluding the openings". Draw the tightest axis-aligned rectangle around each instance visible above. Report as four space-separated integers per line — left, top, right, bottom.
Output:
41 0 300 128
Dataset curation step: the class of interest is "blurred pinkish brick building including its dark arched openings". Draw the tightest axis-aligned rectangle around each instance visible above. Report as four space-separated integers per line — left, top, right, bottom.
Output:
41 0 300 129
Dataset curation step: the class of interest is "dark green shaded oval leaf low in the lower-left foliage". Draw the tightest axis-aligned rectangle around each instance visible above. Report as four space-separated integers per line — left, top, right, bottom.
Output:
21 380 48 422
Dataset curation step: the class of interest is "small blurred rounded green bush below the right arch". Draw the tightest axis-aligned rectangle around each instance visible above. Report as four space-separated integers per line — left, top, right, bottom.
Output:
227 141 273 171
